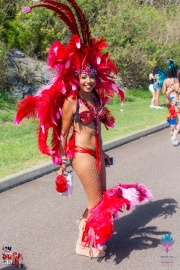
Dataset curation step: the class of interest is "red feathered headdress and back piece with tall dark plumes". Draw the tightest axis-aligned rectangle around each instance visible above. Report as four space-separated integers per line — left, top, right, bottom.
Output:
14 0 124 164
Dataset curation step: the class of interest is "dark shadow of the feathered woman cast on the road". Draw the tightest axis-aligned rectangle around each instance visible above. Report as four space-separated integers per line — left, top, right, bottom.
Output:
103 198 178 264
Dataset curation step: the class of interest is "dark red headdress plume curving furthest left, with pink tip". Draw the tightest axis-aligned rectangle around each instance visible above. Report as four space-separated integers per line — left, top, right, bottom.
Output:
28 4 79 34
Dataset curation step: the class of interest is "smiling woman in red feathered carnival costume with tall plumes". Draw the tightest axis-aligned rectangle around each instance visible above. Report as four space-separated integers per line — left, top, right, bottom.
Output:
14 0 152 257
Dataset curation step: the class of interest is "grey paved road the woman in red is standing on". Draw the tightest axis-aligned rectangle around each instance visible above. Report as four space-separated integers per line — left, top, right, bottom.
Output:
0 129 180 270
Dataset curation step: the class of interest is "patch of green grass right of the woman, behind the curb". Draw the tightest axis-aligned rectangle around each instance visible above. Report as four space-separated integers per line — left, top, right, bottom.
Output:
102 89 168 141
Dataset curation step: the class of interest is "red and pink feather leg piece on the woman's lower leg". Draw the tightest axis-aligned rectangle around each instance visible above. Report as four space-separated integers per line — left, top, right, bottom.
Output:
82 184 153 248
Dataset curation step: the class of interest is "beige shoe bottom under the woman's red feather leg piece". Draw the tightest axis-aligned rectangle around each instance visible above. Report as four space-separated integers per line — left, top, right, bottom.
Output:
76 242 106 258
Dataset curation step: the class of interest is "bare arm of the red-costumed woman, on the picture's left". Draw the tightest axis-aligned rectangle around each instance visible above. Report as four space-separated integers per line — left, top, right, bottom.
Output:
57 98 76 175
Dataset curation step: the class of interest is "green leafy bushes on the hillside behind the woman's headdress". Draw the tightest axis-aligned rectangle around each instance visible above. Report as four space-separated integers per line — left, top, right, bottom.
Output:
0 0 180 87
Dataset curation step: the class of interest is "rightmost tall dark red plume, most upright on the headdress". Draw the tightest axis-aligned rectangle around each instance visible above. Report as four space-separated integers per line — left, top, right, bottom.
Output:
67 0 91 44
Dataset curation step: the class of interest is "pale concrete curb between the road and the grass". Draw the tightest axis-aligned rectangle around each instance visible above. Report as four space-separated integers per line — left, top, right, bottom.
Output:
0 122 169 192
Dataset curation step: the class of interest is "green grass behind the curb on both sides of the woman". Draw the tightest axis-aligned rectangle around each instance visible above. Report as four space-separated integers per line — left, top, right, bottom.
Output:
0 89 168 178
